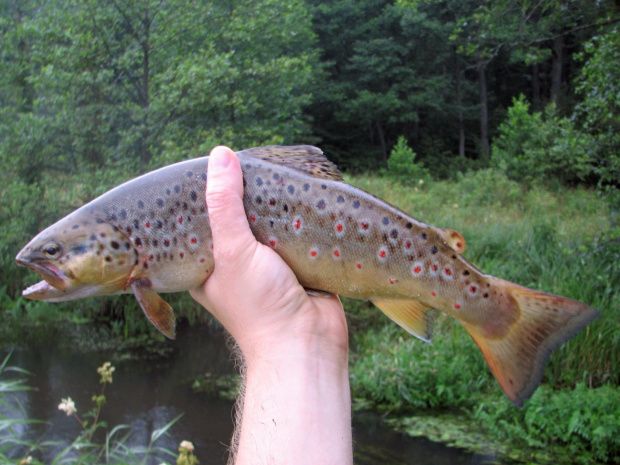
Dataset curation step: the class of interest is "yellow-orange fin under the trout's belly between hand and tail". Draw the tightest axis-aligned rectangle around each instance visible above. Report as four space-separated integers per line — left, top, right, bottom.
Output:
372 299 437 342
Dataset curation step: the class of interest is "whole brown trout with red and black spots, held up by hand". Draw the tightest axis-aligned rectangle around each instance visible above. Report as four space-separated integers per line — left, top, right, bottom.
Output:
16 146 598 405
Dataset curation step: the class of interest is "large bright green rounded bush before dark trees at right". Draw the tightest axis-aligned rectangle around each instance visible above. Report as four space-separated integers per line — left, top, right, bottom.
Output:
492 95 593 184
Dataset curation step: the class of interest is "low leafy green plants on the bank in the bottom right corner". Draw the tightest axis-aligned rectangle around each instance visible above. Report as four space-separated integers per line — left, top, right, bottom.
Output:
473 383 620 464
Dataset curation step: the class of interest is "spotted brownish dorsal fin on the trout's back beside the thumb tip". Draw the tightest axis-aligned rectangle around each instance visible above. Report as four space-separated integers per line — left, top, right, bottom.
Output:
237 145 343 181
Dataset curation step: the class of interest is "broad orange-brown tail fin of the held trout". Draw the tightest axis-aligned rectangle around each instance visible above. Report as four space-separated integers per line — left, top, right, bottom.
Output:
463 278 599 407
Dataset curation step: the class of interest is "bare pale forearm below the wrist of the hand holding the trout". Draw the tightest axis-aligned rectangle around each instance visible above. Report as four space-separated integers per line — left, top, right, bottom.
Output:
235 340 353 465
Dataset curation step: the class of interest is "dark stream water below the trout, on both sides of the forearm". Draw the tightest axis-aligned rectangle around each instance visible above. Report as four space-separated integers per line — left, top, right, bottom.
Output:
2 328 502 465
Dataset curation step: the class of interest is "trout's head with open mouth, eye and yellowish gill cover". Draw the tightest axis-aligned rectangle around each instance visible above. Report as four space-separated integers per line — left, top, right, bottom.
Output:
15 216 138 302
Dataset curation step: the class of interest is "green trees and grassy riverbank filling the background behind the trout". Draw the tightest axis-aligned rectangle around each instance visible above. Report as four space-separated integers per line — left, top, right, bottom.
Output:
0 0 620 463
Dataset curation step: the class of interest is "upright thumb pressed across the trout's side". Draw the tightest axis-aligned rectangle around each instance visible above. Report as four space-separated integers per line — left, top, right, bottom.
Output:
207 146 255 257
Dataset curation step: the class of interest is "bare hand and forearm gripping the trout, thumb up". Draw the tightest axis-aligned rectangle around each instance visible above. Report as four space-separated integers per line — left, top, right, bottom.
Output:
191 147 353 465
